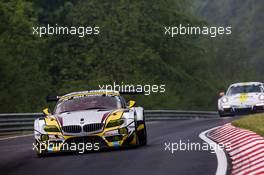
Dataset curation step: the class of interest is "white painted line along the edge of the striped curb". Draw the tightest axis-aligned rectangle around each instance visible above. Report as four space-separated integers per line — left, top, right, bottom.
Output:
199 127 227 175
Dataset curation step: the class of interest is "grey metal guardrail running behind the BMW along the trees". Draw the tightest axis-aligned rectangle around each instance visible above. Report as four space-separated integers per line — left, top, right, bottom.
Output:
0 110 218 135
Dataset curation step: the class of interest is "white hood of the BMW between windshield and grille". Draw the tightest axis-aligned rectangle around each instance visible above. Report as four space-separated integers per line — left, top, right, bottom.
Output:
56 110 112 126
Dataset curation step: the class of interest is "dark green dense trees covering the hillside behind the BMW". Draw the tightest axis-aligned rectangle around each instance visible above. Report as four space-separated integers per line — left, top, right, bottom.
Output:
0 0 262 113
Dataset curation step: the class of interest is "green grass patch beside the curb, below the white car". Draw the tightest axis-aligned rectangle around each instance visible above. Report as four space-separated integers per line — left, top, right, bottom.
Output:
232 114 264 137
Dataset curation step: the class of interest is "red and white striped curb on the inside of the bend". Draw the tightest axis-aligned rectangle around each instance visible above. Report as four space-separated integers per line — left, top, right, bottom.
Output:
207 123 264 175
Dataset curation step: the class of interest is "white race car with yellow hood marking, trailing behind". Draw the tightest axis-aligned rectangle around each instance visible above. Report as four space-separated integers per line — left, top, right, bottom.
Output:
218 82 264 117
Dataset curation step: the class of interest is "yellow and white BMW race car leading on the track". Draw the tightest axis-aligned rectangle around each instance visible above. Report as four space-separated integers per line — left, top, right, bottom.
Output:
34 90 147 156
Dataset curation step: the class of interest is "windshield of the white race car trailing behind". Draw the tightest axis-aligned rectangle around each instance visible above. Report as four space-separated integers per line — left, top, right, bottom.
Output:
227 85 261 95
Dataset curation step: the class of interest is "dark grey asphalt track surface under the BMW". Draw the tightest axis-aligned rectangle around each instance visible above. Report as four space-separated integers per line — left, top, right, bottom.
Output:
0 118 237 175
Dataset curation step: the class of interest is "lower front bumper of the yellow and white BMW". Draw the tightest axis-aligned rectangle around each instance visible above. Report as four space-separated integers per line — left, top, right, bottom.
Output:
34 126 137 154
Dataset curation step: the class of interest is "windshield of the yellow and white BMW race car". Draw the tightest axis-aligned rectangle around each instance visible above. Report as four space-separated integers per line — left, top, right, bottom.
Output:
55 96 122 114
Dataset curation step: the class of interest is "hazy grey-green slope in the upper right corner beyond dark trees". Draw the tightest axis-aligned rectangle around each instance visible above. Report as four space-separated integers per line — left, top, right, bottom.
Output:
194 0 264 74
